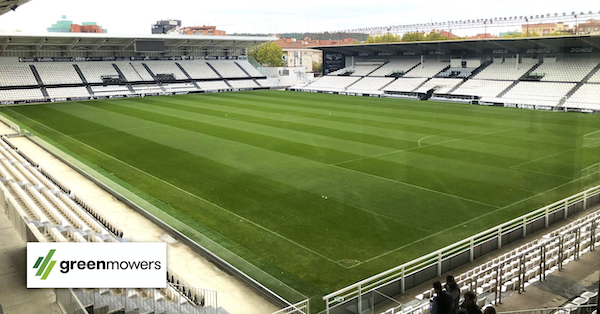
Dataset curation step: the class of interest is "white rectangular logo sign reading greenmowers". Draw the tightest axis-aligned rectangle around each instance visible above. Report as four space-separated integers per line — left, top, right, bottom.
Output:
27 242 167 288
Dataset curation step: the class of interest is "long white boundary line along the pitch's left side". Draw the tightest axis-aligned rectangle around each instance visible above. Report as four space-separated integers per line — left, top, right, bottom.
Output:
8 109 351 269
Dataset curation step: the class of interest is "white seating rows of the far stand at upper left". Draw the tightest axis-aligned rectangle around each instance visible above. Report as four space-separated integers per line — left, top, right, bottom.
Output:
0 60 273 102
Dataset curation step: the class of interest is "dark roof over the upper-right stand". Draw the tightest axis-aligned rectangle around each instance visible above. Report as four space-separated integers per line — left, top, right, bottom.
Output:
311 35 600 55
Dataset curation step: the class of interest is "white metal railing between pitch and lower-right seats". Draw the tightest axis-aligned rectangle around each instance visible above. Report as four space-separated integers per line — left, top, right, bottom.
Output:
323 185 600 313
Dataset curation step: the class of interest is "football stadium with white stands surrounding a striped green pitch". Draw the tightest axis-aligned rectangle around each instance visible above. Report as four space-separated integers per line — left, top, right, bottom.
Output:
0 1 600 314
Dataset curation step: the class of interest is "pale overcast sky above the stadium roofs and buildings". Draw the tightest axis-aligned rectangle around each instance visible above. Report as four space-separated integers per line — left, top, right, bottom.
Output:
0 0 600 36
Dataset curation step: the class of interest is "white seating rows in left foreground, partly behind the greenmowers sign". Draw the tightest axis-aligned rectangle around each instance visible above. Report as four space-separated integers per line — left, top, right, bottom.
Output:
0 138 211 313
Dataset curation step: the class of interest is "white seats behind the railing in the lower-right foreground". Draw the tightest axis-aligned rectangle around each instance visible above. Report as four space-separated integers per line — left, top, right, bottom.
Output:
382 212 600 314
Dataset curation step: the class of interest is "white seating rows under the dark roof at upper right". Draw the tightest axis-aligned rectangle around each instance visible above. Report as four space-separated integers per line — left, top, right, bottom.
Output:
302 58 600 110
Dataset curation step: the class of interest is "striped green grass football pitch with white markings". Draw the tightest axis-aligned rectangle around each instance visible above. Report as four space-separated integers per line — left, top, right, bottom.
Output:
0 91 600 302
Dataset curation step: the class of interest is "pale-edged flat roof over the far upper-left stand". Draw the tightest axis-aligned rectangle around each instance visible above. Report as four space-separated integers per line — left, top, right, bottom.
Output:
0 32 277 56
